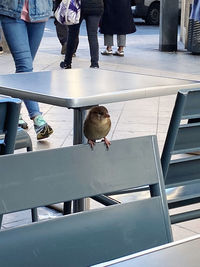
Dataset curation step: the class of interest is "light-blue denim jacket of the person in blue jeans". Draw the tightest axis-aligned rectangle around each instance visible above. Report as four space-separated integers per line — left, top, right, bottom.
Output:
0 0 53 22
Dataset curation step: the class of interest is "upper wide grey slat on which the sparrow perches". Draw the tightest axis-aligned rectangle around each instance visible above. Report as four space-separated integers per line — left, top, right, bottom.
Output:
0 137 160 214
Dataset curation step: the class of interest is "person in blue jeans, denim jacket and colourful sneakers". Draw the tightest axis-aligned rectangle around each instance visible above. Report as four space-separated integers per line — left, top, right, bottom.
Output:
0 0 53 140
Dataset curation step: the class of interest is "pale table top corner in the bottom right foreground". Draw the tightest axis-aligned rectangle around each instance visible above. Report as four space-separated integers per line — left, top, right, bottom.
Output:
95 235 200 267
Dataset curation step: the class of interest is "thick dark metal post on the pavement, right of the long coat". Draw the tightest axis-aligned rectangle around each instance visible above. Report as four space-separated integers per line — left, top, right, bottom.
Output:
159 0 179 52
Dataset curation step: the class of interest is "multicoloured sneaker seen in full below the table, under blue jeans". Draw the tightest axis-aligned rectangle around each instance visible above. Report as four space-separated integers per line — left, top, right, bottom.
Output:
33 115 53 140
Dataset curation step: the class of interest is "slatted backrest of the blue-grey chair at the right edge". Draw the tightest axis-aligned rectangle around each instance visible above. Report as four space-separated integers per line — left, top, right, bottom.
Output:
161 89 200 188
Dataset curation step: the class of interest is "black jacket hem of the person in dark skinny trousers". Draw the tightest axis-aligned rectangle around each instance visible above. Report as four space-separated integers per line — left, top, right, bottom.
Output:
81 0 104 16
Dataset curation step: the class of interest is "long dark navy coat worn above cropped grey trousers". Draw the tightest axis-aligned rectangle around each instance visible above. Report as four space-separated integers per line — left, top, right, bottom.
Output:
100 0 136 35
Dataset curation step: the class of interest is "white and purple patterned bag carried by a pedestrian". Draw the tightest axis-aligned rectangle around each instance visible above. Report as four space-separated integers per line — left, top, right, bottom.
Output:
55 0 81 25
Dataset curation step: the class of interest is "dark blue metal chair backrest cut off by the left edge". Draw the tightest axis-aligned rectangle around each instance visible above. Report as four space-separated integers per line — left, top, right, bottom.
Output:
0 97 21 155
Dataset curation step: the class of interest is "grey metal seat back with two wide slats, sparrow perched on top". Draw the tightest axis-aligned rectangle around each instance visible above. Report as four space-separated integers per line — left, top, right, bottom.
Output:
0 136 172 267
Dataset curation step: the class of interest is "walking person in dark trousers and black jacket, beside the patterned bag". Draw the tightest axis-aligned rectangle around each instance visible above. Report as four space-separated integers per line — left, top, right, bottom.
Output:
60 0 104 69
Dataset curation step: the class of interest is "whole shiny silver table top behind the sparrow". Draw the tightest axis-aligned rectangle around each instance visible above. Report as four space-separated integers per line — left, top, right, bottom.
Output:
0 69 200 108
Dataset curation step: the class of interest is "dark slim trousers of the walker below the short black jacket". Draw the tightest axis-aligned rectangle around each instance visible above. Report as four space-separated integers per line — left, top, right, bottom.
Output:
65 15 101 65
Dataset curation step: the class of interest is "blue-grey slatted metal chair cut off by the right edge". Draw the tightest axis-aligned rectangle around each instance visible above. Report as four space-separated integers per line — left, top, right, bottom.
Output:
161 89 200 223
